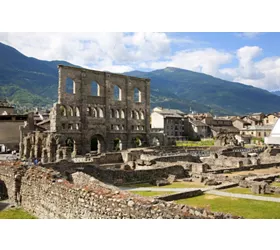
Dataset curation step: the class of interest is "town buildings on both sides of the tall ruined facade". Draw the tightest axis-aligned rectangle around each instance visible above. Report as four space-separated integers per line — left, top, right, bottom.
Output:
0 95 280 152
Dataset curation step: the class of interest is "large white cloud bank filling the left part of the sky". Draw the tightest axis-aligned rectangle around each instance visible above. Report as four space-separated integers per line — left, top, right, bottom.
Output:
0 32 170 70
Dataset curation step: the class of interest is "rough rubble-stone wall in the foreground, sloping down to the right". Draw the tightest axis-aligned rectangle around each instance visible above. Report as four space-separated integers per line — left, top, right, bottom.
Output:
0 165 241 219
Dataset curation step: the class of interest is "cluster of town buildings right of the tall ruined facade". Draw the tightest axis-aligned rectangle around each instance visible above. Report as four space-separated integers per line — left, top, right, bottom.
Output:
151 107 280 146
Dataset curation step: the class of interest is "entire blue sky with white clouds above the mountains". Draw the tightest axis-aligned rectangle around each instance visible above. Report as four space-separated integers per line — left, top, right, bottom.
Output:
0 32 280 90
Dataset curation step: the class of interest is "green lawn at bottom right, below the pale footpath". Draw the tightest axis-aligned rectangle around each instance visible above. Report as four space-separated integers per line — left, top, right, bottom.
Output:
177 194 280 219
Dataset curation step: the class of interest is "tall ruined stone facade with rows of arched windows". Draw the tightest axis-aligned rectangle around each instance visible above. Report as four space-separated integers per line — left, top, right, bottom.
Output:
20 65 150 163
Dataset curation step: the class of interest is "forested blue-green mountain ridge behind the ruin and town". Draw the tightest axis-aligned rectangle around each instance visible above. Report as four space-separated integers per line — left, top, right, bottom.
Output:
0 43 280 115
